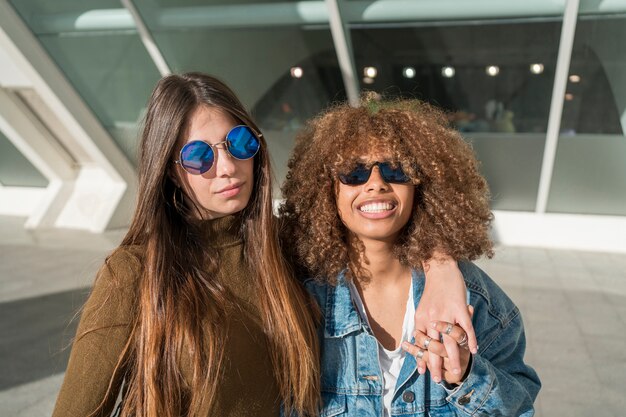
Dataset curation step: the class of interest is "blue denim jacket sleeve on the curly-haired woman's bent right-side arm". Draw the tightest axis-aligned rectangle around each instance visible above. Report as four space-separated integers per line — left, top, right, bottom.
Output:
448 312 541 417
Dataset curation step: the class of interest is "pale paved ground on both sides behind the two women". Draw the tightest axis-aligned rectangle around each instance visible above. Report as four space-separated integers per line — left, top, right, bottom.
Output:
0 217 626 417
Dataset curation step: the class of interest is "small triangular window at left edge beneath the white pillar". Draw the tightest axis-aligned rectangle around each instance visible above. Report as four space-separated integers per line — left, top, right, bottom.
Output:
0 128 48 187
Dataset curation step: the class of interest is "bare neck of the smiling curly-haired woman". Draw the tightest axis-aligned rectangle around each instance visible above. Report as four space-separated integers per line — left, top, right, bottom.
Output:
350 232 410 287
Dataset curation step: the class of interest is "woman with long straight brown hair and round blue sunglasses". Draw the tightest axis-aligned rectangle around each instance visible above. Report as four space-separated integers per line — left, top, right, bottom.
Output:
54 73 319 417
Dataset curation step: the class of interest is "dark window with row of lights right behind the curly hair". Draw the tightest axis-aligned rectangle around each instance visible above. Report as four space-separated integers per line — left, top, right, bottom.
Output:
350 19 561 210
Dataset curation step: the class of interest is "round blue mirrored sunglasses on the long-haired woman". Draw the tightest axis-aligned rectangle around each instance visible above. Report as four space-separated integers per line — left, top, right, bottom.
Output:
175 125 262 175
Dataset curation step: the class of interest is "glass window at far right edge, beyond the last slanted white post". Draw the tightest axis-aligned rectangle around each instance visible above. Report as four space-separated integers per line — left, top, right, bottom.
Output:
547 14 626 215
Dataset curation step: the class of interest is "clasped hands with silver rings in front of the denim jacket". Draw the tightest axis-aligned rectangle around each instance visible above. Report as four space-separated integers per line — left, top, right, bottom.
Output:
402 321 470 384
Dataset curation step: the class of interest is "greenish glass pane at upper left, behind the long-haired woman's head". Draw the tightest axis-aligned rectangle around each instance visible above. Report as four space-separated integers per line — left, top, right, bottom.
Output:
11 0 160 161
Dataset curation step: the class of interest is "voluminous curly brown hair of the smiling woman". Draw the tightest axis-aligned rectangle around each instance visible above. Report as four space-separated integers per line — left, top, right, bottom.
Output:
279 100 493 284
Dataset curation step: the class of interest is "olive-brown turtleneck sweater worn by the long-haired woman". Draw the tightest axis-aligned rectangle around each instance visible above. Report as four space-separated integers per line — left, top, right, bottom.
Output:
53 216 280 417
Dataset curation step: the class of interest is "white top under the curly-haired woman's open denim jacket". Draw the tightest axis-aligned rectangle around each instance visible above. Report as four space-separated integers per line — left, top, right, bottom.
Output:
350 280 415 417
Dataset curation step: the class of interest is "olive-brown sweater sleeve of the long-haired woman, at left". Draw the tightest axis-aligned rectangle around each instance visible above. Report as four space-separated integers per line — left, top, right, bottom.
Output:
53 250 141 417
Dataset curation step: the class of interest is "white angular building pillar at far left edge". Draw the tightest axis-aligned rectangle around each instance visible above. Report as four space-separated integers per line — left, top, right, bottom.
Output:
0 0 136 232
